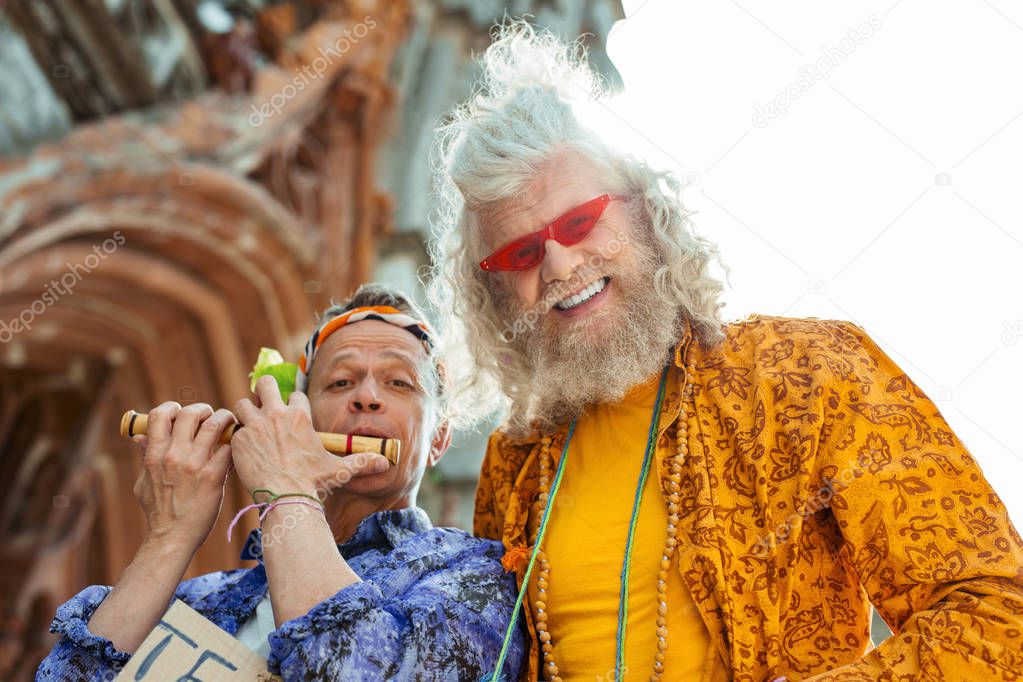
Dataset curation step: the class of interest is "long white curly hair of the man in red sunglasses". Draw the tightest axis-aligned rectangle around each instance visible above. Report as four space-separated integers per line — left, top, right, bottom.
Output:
428 19 727 430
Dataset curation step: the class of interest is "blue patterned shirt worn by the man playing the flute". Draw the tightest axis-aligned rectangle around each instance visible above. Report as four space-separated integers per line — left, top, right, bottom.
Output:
36 507 523 682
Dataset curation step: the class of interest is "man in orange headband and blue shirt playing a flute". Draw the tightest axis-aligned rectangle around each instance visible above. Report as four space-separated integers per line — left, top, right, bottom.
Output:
37 285 523 680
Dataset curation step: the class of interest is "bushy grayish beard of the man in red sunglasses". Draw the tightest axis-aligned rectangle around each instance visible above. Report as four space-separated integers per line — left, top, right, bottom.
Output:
503 235 683 430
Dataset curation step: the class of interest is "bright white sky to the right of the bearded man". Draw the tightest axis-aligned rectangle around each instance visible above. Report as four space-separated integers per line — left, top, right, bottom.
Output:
608 0 1023 529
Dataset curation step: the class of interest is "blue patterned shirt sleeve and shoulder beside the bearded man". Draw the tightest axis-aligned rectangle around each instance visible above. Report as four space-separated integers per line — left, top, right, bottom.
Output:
269 529 524 680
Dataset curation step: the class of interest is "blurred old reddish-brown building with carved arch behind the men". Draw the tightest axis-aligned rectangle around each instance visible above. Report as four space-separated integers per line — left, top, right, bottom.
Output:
0 0 621 680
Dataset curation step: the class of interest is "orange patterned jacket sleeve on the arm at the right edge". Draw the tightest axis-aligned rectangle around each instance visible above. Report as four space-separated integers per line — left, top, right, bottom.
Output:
811 322 1023 681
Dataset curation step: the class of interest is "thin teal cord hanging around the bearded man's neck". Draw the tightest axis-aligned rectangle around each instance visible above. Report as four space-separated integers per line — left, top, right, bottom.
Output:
484 367 668 682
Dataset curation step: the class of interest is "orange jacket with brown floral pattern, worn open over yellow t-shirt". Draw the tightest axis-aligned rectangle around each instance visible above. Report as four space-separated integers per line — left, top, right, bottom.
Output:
475 316 1023 682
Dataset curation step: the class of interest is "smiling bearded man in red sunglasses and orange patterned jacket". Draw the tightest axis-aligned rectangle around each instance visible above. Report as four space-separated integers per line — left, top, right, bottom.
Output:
432 22 1023 681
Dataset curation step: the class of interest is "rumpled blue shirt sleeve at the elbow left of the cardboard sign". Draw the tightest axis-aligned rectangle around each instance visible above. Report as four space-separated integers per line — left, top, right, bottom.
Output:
36 585 131 682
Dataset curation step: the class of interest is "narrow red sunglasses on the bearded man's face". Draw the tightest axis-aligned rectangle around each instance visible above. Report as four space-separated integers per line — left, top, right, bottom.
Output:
480 194 628 272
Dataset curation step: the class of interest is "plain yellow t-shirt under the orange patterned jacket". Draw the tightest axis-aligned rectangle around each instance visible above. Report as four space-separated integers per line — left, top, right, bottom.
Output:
529 374 716 680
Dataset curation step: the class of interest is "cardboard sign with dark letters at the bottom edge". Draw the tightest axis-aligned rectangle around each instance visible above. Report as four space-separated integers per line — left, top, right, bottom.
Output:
117 599 280 682
